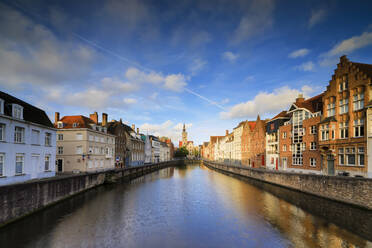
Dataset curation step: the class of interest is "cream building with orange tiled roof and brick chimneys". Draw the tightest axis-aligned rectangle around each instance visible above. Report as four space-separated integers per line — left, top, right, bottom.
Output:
54 112 115 172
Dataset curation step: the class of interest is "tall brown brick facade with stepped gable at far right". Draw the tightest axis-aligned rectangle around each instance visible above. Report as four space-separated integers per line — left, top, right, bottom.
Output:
319 56 372 177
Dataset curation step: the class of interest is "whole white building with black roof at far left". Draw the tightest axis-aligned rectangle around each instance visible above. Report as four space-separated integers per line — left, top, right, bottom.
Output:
0 92 56 185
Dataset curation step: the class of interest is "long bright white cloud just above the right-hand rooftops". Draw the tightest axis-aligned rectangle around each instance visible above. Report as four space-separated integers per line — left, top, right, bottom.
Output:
220 85 313 119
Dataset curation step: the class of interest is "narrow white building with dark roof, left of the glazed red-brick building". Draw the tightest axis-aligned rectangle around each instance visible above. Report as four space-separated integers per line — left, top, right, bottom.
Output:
265 111 289 170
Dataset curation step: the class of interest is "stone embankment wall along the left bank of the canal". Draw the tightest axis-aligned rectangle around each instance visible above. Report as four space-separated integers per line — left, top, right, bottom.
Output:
0 160 184 226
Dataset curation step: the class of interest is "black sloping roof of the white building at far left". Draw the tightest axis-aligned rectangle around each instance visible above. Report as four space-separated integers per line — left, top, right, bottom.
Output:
0 91 53 127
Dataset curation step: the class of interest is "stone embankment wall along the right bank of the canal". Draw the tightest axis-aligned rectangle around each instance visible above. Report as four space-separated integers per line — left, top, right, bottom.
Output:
203 161 372 210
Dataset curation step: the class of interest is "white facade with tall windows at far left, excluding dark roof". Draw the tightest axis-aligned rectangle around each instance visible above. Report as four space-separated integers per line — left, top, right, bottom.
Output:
0 109 56 185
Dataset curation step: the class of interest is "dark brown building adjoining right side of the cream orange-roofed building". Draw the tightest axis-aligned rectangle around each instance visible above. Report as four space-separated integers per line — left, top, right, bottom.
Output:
106 118 133 168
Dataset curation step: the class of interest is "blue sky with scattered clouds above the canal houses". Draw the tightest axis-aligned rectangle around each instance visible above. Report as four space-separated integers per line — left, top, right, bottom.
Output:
0 0 372 144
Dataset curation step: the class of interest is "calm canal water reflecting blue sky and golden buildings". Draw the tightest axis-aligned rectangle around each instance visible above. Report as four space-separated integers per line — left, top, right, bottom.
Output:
0 165 372 248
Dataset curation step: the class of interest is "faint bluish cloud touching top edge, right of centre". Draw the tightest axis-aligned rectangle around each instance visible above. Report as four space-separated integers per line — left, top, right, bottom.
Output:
233 0 275 44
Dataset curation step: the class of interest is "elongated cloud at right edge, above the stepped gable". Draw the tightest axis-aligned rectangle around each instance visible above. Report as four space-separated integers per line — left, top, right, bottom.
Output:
327 32 372 56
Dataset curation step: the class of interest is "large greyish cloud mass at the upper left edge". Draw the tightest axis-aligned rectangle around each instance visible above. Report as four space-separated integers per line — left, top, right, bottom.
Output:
0 4 96 88
